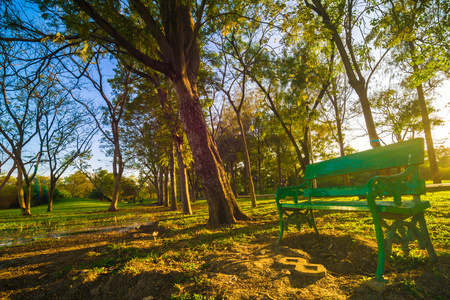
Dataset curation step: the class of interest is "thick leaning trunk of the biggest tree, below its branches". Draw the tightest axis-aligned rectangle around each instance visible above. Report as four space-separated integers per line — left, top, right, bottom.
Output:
173 76 250 225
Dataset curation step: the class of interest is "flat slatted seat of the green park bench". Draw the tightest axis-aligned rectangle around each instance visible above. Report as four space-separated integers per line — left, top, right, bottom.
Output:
281 201 430 216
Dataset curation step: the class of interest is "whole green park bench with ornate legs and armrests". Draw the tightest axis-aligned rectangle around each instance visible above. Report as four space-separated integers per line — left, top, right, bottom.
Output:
275 138 437 281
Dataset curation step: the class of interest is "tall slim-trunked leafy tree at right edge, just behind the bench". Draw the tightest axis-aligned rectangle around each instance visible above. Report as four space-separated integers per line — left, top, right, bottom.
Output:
373 1 450 183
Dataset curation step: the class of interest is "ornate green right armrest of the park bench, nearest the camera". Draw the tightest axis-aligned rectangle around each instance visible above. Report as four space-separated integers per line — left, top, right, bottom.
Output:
366 165 425 206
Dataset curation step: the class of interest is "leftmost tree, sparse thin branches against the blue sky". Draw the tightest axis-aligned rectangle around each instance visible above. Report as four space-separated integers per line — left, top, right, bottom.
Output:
0 43 50 216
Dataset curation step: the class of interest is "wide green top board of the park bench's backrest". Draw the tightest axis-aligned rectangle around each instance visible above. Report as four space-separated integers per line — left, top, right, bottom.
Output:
305 138 424 179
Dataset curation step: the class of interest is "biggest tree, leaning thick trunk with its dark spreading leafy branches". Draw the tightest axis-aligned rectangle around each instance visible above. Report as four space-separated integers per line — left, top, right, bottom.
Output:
43 0 249 225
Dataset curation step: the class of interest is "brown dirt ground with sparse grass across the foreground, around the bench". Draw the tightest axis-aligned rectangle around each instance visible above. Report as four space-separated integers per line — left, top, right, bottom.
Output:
0 223 450 300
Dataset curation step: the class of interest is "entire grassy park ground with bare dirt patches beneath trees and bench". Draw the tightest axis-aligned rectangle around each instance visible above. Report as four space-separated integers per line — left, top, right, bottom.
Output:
0 191 450 299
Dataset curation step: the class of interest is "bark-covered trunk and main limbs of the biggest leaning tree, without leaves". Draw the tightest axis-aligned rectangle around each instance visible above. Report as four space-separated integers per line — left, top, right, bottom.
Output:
74 0 250 225
